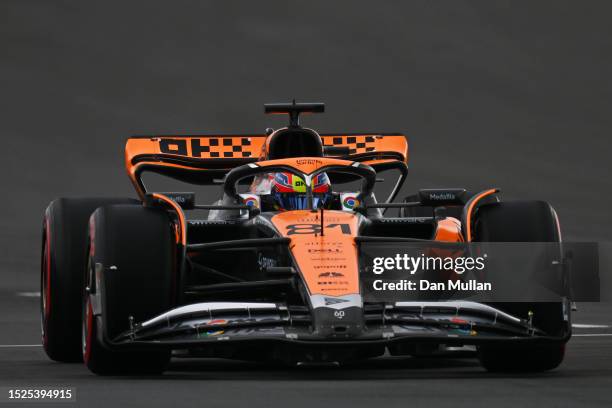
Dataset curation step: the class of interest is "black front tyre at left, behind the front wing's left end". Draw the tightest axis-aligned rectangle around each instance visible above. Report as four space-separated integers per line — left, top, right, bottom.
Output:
82 205 176 375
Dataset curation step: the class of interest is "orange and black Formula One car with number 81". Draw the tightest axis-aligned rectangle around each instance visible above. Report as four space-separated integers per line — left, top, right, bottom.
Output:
41 101 571 374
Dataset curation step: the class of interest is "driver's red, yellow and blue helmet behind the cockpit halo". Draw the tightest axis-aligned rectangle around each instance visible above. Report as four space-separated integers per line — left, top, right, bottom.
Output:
271 173 332 211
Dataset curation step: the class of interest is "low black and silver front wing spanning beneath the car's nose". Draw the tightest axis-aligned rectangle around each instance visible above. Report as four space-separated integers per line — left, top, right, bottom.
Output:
107 301 571 348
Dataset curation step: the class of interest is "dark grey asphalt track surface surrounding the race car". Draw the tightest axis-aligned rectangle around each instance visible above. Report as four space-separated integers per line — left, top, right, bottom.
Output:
0 0 612 407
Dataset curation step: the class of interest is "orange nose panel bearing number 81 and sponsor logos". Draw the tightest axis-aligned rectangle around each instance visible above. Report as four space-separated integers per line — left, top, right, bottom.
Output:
272 210 359 296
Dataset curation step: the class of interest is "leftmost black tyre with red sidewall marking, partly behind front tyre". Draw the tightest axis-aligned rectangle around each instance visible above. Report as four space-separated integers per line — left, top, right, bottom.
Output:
40 198 138 362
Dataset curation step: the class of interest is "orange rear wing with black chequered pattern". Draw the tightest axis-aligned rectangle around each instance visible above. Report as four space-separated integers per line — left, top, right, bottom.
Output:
125 133 408 197
